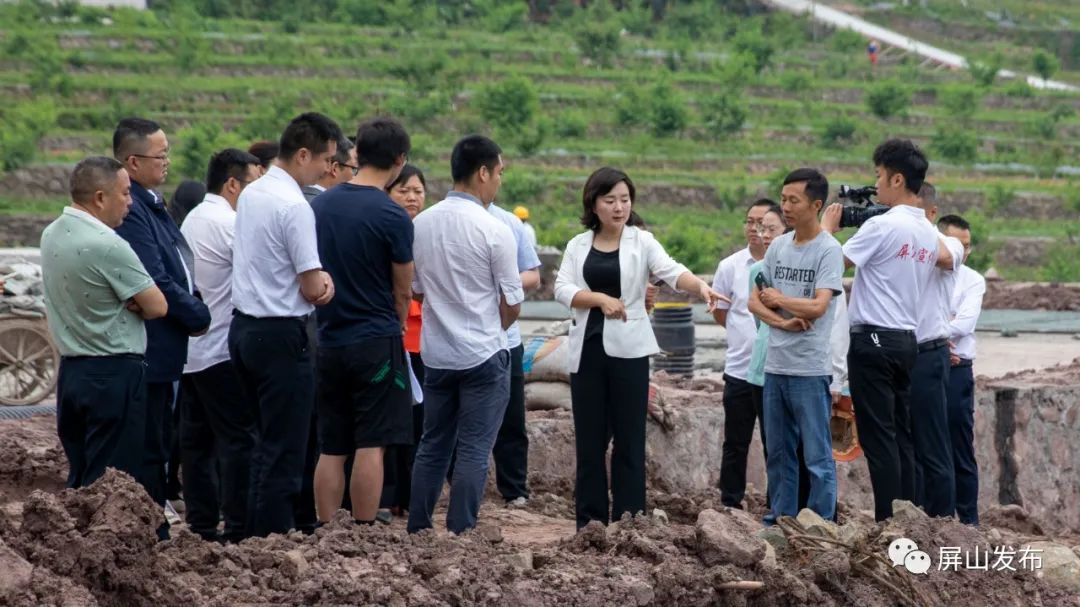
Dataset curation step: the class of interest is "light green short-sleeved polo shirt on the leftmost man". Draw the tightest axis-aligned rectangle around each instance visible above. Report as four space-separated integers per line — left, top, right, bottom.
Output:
41 206 153 356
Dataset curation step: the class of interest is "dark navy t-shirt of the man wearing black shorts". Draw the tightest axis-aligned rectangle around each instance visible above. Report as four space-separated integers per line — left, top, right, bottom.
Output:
311 184 413 348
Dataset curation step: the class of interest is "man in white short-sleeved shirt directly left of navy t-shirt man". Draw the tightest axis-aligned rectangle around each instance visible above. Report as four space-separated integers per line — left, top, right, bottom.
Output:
229 112 341 537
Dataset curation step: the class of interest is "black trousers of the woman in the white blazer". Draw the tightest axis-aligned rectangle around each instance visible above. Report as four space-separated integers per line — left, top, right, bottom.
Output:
570 335 649 529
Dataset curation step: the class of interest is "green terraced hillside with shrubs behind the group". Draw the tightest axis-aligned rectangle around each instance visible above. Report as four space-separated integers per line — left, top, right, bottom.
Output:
0 0 1080 280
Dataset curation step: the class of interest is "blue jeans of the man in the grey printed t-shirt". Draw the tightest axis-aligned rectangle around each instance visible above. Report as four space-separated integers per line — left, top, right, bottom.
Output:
764 373 836 524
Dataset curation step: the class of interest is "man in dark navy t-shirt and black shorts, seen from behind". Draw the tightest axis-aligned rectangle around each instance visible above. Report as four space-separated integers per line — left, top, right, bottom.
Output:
311 118 413 524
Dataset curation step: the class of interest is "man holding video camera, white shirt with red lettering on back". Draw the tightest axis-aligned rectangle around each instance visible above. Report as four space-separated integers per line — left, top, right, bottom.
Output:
822 139 953 521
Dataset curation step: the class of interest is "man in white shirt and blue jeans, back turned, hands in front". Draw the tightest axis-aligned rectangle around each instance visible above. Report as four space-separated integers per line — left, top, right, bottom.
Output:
408 135 525 534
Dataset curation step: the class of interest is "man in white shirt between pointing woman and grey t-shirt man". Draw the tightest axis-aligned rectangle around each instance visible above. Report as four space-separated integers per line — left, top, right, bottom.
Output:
713 198 782 508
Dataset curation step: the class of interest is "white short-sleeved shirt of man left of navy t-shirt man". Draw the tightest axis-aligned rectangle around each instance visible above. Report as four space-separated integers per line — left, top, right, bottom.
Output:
232 166 322 319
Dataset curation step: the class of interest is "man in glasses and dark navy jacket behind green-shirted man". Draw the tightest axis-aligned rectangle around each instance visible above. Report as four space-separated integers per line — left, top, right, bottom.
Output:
112 118 211 539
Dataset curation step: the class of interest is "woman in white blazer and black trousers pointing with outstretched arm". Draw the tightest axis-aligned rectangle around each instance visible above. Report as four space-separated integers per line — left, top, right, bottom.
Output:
555 167 727 529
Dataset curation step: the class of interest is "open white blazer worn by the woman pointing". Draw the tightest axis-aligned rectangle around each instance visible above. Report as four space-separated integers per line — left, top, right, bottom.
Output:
555 226 689 373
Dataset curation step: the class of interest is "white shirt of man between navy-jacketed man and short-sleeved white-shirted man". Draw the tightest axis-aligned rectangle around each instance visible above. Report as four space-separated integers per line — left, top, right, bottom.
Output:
180 193 237 374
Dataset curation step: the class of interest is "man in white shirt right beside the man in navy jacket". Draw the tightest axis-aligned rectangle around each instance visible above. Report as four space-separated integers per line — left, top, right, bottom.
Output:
179 148 259 542
